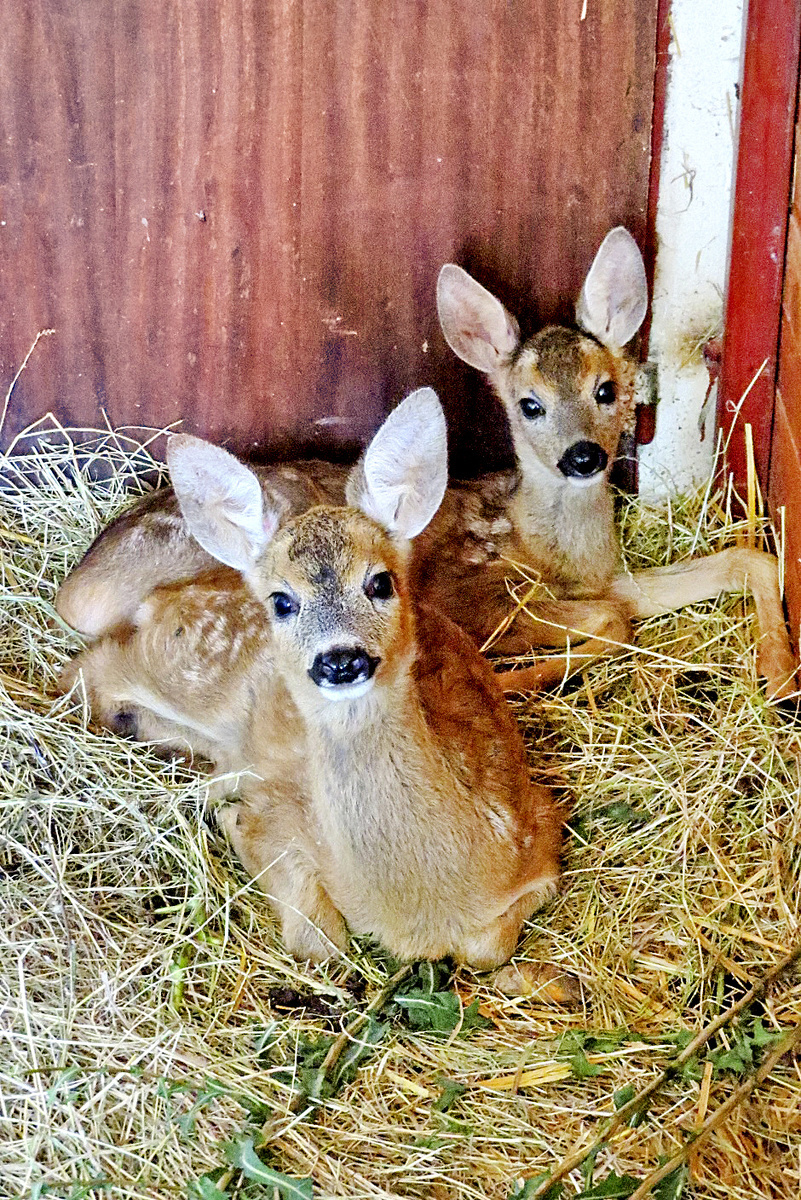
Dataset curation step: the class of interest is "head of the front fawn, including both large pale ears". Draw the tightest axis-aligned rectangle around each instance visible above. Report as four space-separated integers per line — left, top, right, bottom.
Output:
168 388 447 700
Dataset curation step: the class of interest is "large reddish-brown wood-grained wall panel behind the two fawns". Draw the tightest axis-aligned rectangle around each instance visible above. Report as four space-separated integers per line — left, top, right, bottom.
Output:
0 0 657 467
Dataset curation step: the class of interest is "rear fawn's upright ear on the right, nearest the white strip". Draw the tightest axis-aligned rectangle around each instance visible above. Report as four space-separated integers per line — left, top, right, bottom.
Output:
576 226 648 349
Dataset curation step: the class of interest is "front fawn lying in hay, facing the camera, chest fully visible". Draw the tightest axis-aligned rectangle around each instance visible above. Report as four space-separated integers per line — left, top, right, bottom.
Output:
64 389 561 968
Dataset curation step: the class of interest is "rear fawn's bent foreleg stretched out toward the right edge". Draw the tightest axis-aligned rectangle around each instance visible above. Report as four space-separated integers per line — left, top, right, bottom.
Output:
609 547 796 700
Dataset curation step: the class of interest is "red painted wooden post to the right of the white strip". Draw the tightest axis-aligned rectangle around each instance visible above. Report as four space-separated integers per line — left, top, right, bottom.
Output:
718 0 801 488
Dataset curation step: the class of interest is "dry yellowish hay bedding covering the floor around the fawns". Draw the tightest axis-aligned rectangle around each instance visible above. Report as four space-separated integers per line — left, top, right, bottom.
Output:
0 420 801 1200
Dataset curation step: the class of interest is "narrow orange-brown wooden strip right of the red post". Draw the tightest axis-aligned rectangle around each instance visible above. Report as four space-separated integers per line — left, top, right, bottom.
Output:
769 102 801 648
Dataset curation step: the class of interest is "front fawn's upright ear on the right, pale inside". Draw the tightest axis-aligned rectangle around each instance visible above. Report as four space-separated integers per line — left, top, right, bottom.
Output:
347 388 447 538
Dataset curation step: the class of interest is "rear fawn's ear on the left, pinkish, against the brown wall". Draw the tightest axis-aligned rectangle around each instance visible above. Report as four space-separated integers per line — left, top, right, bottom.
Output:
436 263 520 374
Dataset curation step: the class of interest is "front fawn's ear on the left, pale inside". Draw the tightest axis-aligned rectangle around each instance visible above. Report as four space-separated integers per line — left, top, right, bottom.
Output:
167 433 278 571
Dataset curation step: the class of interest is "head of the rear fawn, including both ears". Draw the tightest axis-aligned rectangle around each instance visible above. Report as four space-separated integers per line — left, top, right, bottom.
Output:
436 226 648 486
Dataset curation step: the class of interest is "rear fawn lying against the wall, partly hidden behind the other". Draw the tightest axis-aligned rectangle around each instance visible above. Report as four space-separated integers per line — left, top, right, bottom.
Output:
56 228 795 697
